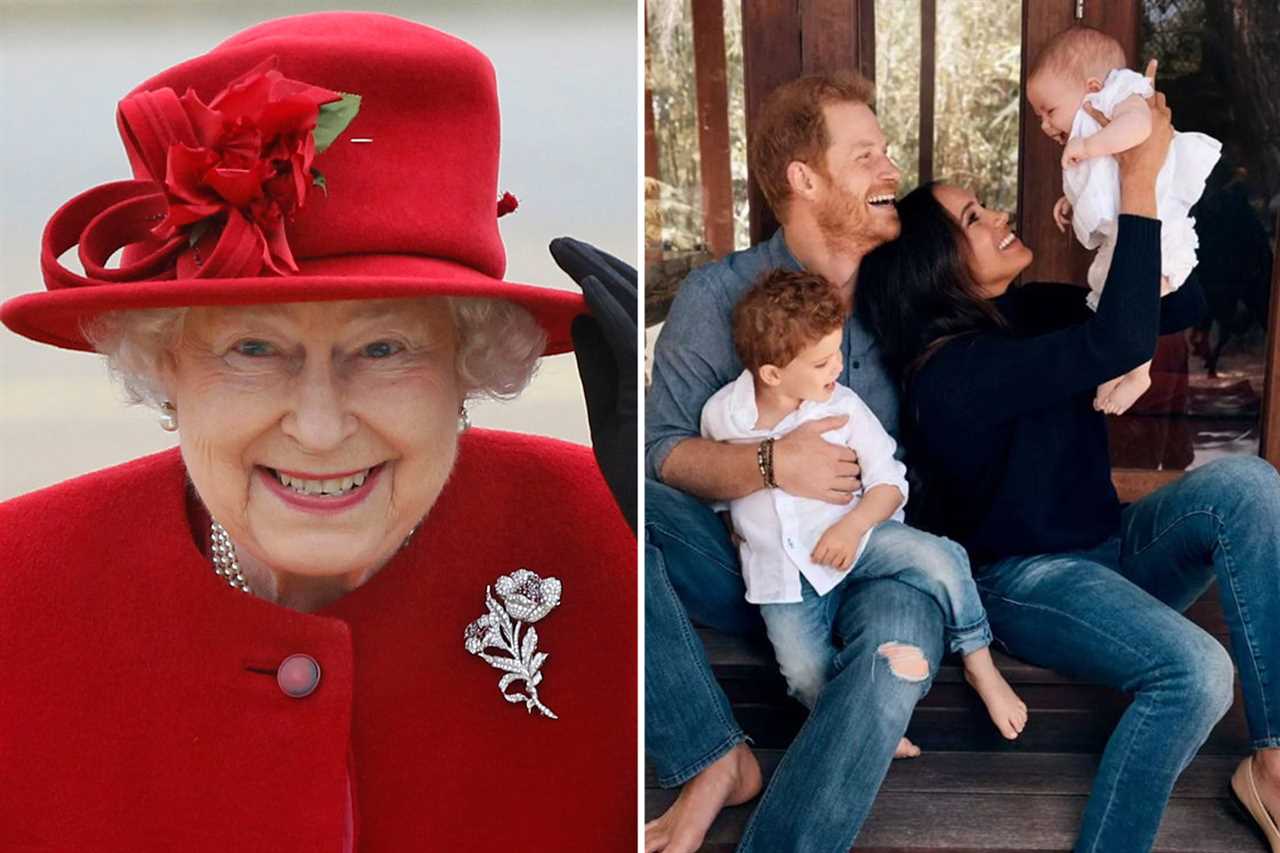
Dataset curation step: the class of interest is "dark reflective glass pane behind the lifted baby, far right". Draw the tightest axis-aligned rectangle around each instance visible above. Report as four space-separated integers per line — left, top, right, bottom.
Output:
1111 0 1280 469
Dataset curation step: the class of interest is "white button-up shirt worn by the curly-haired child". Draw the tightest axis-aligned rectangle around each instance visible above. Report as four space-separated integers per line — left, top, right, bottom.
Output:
701 370 906 605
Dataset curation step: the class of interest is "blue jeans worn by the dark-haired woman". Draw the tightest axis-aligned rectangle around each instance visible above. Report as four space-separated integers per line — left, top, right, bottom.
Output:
977 457 1280 853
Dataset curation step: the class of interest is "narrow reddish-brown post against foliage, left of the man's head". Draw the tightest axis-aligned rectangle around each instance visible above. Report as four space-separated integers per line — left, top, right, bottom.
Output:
692 0 733 257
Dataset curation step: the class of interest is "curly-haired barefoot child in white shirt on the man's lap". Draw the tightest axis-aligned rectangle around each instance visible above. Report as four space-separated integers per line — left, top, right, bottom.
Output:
701 270 1027 739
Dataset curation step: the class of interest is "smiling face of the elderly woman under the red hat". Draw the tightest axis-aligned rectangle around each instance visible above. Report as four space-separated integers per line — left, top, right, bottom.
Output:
164 298 462 587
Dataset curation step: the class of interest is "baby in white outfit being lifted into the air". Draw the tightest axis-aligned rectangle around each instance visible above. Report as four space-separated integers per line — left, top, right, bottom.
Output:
1027 26 1222 415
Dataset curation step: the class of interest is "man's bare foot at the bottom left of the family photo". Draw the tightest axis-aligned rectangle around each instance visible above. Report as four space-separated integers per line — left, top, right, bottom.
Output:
644 743 762 853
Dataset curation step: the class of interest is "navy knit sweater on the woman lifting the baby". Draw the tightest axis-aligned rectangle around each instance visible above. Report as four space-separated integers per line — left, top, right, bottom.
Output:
906 215 1203 565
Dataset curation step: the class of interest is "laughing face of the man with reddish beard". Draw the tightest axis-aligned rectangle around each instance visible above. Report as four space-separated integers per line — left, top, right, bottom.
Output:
810 101 902 254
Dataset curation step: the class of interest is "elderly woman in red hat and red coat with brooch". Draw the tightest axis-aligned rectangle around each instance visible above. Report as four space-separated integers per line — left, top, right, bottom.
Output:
0 13 636 850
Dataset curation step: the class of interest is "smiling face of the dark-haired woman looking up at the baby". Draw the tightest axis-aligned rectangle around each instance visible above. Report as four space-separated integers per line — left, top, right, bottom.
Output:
933 183 1034 298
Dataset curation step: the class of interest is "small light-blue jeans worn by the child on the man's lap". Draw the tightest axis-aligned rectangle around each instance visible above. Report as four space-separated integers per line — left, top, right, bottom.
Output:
760 521 991 708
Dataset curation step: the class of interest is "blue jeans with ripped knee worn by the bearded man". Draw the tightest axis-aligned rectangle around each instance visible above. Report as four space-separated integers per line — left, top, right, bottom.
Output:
644 480 942 853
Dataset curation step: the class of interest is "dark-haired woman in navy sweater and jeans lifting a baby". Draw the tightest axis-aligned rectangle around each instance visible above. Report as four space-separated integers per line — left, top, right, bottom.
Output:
856 81 1280 850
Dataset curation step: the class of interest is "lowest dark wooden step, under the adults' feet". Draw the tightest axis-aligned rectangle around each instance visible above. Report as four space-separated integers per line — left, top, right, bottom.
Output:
645 749 1267 853
